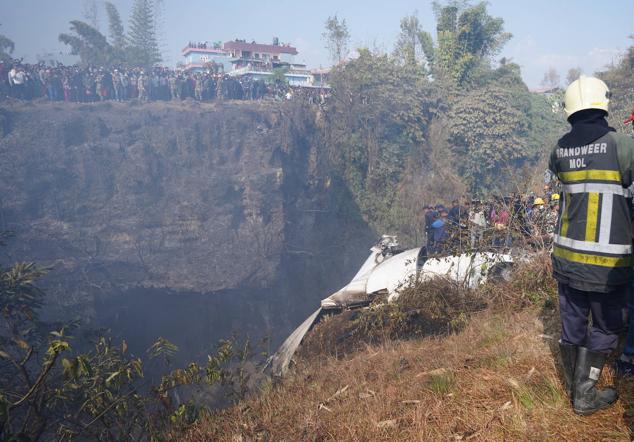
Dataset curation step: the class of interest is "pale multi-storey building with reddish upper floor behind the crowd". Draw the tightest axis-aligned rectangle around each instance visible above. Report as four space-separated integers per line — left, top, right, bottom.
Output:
182 39 314 86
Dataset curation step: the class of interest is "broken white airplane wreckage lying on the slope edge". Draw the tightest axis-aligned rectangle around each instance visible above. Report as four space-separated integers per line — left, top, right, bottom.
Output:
267 235 513 376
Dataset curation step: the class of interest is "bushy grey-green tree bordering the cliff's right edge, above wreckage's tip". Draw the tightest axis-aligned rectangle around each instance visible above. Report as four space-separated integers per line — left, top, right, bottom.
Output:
328 48 435 241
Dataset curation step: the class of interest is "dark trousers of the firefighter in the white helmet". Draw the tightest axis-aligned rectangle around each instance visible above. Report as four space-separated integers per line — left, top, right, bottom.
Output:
559 283 629 354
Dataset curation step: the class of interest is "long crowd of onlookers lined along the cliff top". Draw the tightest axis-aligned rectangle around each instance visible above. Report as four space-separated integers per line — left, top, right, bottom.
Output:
0 61 327 104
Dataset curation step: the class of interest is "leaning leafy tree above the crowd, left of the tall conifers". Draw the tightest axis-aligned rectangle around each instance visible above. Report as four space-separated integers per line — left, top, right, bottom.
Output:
59 20 117 66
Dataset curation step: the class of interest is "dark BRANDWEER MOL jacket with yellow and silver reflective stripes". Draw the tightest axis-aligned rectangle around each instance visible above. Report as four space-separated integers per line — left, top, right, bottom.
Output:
549 132 634 293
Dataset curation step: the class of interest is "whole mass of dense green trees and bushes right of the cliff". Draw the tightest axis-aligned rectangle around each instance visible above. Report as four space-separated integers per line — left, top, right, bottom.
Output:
326 3 566 242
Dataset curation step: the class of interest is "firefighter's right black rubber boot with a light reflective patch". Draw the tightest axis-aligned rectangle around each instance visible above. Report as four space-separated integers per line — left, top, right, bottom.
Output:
572 347 618 416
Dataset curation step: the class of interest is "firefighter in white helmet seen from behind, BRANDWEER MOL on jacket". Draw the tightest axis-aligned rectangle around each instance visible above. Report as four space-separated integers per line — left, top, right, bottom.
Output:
549 76 634 415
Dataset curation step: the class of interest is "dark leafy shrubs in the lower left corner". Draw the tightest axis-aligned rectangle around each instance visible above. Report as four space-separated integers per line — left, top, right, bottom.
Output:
0 232 262 441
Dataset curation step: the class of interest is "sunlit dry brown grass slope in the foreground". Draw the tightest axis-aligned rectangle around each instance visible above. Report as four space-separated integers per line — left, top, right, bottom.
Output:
175 254 634 441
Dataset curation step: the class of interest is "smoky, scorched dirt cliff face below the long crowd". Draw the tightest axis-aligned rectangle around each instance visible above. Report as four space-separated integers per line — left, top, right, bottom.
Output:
0 103 374 362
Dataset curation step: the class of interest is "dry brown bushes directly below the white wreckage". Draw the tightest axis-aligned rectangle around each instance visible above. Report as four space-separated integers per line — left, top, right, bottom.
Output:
299 252 556 357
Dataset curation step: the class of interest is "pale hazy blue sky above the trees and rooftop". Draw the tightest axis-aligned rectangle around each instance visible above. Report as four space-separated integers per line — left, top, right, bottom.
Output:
0 0 634 87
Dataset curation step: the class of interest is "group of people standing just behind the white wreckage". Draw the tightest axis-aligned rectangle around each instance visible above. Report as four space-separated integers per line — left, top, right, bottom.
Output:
424 186 559 254
